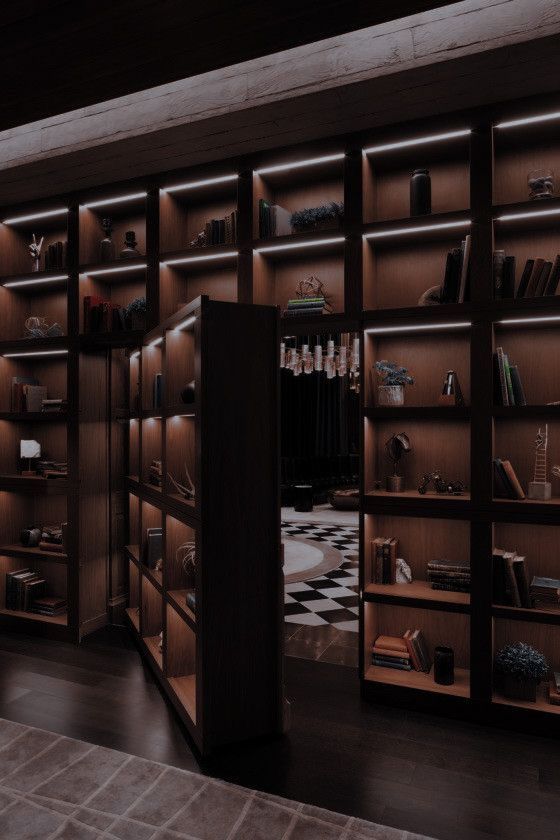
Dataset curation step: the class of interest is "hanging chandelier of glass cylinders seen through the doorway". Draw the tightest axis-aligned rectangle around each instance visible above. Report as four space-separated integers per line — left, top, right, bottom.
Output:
280 333 360 392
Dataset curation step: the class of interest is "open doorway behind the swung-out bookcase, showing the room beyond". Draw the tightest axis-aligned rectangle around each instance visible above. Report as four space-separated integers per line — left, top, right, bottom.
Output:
280 333 360 667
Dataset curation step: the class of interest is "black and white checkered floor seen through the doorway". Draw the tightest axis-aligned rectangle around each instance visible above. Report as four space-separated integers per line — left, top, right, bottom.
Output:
282 522 359 633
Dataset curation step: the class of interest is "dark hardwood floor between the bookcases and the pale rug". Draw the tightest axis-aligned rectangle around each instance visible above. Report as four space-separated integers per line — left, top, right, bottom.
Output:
0 629 560 840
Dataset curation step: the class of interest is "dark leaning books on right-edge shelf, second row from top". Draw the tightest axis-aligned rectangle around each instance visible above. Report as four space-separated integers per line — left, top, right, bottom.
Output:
493 251 560 299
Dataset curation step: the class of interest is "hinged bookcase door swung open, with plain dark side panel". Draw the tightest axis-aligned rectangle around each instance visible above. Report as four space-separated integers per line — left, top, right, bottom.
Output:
125 297 283 752
